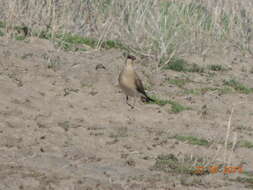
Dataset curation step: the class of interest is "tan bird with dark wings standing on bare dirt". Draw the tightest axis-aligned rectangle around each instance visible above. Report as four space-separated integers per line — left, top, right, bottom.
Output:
118 55 154 109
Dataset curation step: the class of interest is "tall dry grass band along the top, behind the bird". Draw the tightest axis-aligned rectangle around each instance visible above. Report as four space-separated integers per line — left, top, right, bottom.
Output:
0 0 253 66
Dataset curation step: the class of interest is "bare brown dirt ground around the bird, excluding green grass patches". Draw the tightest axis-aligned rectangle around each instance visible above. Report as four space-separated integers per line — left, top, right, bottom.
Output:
0 37 253 190
